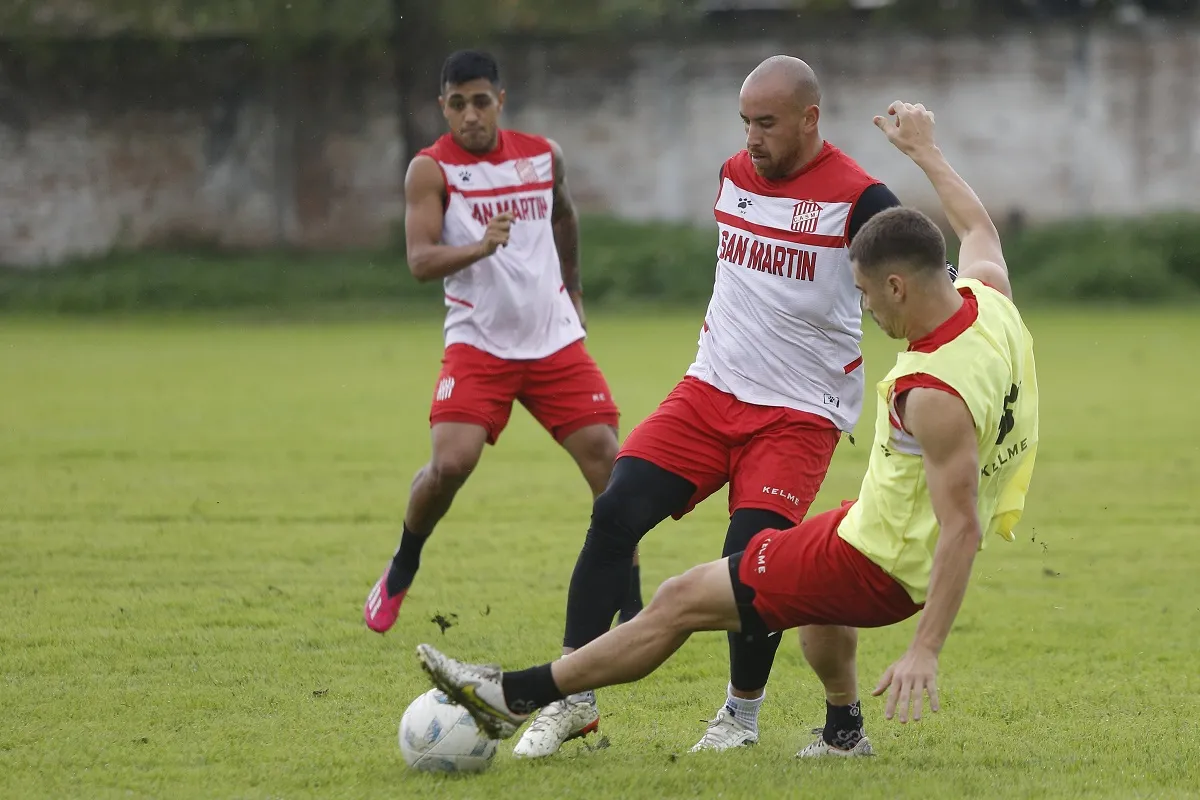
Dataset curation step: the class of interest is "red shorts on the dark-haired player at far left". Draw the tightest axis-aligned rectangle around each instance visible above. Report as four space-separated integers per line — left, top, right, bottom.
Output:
430 339 620 445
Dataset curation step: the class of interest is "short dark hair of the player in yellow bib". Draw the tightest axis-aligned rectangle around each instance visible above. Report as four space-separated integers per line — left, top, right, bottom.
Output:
850 206 946 273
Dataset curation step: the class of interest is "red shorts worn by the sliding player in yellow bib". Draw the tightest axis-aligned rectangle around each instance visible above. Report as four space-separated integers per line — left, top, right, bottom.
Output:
730 503 922 631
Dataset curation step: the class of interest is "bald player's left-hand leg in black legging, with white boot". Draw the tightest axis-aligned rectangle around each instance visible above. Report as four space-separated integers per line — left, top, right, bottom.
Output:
512 457 696 758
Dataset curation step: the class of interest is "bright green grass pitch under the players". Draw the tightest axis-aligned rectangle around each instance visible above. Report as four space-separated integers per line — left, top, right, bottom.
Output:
0 311 1200 798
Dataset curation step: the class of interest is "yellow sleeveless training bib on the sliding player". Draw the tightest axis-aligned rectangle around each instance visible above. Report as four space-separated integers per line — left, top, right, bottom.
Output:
838 278 1038 603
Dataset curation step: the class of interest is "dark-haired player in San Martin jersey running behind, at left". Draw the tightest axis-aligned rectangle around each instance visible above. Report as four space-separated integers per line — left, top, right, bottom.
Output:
362 50 642 633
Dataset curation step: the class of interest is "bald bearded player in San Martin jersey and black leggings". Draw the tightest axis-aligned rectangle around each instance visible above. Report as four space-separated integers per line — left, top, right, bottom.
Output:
514 56 955 757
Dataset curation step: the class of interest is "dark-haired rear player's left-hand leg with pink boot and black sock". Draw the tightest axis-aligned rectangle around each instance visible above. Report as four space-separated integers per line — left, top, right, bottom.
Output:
362 422 487 633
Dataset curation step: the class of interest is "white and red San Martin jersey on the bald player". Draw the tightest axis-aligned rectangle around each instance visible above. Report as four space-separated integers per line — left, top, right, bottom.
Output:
688 143 880 431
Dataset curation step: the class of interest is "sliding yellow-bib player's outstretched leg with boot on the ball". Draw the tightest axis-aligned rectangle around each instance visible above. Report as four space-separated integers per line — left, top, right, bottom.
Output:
416 559 742 739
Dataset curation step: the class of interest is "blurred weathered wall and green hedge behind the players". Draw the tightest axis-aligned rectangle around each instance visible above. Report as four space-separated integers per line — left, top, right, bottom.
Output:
0 0 1200 311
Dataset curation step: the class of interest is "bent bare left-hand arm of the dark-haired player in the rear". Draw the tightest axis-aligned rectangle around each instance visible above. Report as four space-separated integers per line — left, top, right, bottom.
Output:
404 156 512 283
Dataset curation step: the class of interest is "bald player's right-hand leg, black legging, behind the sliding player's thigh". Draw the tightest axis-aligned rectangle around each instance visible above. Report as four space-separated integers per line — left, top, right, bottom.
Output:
691 509 793 752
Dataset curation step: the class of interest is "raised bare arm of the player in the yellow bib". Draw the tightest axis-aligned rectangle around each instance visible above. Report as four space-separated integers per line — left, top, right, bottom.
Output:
875 101 1013 299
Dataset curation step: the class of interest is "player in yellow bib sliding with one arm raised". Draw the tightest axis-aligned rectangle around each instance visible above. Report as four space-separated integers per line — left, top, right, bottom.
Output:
418 102 1038 757
